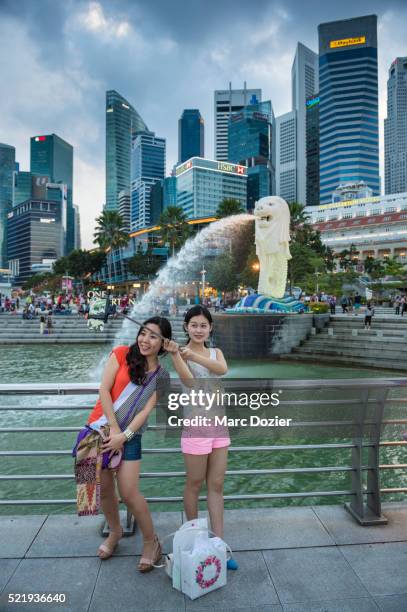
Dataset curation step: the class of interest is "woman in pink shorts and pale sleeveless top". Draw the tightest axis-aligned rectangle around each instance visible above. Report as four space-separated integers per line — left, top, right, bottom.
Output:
168 305 237 569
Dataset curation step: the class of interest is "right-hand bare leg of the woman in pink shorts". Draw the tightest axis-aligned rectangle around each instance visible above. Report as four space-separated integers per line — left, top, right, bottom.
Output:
206 446 228 538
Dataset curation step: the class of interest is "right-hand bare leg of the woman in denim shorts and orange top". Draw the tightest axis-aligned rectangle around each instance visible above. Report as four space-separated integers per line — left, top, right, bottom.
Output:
117 461 154 559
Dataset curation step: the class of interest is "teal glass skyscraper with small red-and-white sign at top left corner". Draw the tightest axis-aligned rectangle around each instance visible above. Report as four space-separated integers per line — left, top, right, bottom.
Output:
30 134 75 254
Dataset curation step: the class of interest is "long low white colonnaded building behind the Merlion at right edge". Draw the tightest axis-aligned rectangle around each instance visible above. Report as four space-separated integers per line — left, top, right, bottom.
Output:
309 193 407 263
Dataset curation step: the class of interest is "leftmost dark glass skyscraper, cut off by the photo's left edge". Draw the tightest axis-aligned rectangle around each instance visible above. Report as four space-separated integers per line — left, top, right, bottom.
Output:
0 143 16 268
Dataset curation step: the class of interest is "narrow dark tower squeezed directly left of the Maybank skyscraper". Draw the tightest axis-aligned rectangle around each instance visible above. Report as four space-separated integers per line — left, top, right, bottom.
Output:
305 96 319 206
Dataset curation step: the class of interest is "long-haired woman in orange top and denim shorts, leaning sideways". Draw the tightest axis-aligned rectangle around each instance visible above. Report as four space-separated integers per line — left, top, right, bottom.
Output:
88 317 171 572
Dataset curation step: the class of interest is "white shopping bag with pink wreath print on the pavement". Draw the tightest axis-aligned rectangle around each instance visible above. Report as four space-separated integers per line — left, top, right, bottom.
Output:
181 533 226 599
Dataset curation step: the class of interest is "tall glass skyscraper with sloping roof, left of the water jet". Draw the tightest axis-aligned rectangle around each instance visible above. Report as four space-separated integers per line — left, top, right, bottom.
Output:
105 90 148 210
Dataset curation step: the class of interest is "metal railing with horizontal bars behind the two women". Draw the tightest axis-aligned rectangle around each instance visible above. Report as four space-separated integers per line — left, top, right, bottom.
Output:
0 378 407 525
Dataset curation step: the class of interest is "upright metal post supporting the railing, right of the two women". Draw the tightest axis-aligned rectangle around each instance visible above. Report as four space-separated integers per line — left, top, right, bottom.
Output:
345 389 388 526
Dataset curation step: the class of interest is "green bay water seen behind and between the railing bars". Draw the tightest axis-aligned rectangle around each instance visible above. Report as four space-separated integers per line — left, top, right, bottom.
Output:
0 345 407 514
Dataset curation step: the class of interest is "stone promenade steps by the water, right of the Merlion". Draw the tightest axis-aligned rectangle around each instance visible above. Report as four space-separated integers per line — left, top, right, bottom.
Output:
281 313 407 371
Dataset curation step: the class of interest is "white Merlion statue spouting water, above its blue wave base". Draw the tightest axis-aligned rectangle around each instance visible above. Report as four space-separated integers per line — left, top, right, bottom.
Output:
254 196 291 298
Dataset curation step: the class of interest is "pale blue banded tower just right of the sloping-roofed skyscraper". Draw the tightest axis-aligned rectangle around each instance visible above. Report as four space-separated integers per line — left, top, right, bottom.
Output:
130 131 165 231
